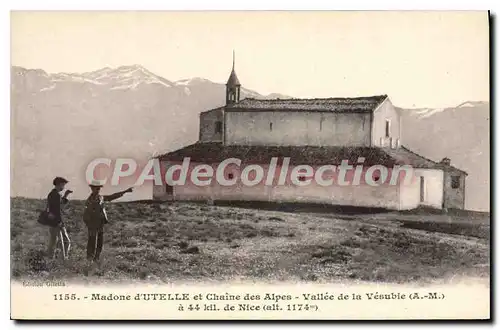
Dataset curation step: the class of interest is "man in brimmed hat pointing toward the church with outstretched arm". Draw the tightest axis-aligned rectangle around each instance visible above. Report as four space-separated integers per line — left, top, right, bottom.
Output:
83 182 132 262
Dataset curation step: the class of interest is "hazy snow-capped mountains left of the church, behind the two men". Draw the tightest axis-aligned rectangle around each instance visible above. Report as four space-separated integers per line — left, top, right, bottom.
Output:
11 65 287 198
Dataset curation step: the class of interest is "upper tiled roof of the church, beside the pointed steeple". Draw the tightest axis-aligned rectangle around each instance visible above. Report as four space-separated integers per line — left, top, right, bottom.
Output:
226 95 387 112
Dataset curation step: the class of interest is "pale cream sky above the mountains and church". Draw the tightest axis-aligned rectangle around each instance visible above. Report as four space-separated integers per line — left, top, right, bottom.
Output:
11 12 489 107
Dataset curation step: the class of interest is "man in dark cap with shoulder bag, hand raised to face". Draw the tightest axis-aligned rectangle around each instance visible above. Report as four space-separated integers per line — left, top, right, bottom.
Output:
47 177 72 259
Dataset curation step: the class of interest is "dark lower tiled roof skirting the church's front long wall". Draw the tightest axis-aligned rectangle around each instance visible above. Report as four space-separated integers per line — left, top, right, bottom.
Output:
158 142 395 166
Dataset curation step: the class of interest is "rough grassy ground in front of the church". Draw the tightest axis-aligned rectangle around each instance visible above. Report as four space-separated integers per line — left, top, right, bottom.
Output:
11 198 490 283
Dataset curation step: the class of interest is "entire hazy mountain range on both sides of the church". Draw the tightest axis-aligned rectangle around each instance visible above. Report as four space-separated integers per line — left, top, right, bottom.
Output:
11 65 490 210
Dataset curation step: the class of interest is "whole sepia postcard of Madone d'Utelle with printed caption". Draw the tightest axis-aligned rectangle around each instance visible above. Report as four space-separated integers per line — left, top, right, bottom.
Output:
10 11 491 320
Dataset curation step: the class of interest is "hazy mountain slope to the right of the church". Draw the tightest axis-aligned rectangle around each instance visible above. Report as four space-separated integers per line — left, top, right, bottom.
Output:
401 101 491 210
